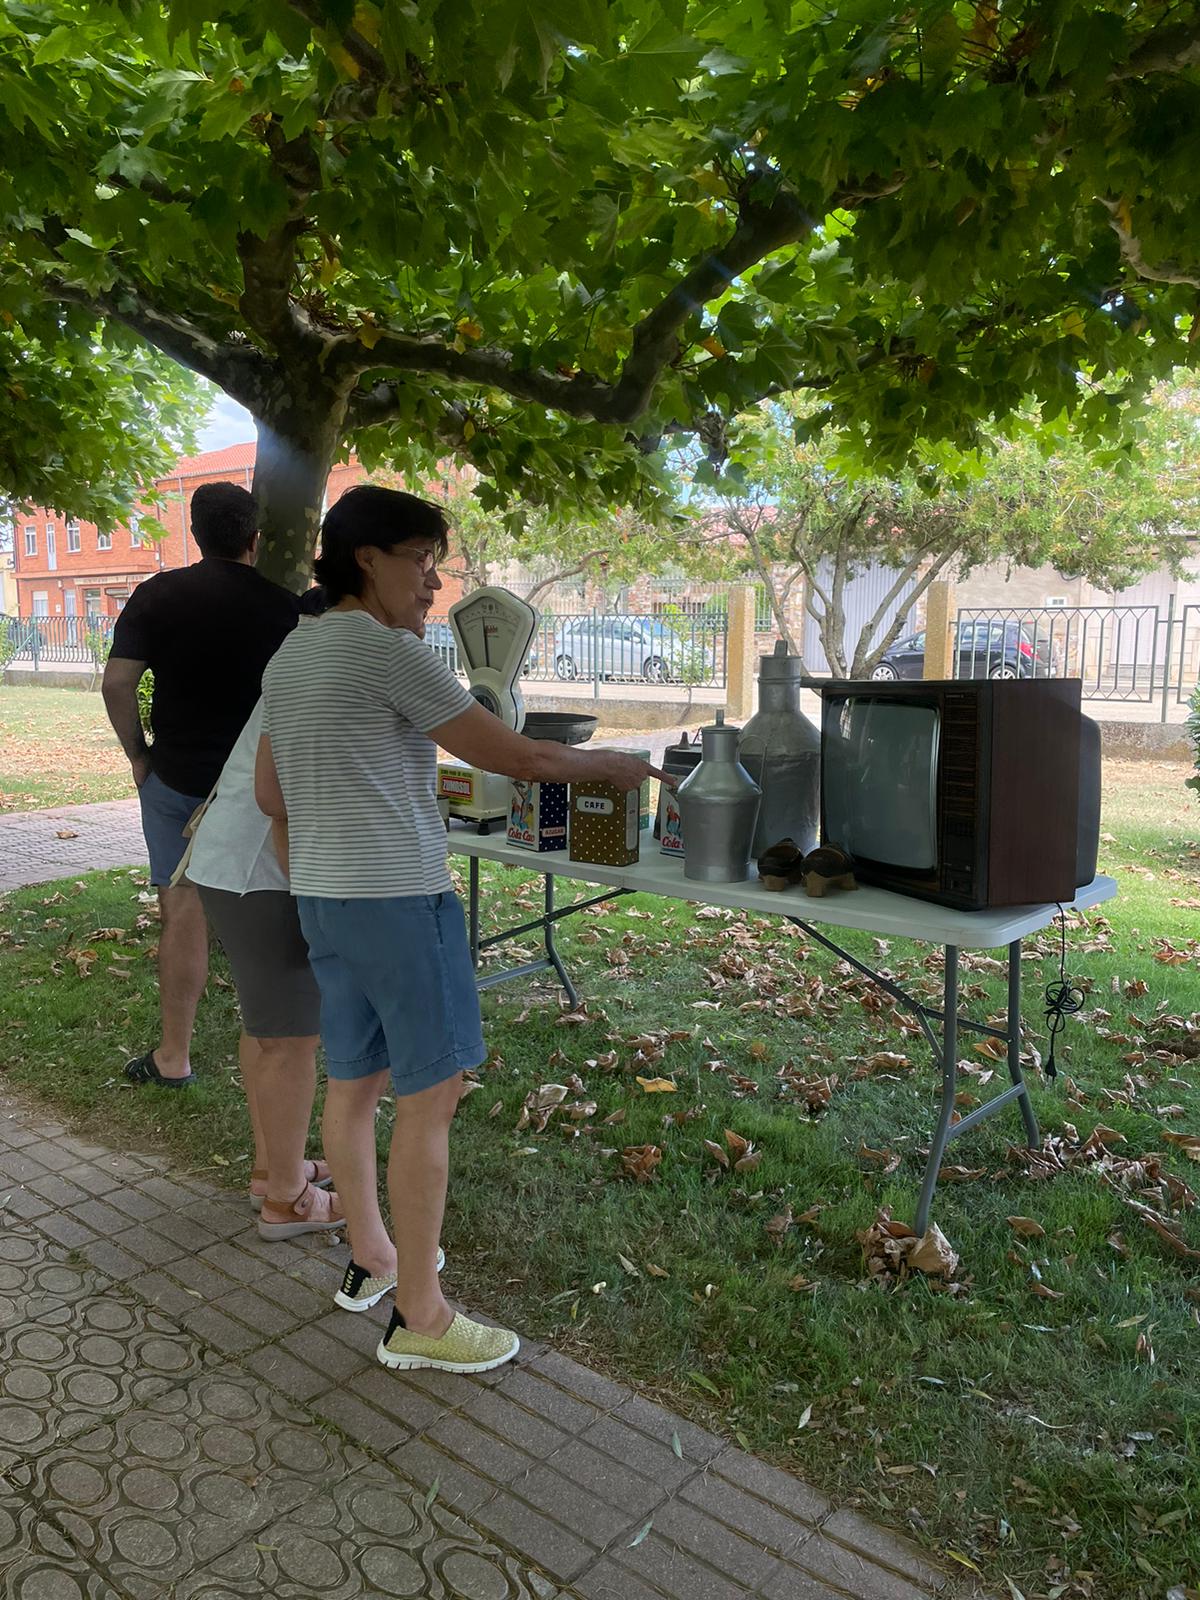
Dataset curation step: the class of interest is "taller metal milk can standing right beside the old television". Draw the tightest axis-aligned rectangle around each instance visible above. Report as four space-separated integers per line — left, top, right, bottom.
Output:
738 638 821 859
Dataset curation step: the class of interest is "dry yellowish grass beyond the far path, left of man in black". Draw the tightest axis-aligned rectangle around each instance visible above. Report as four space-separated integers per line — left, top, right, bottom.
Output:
0 680 134 811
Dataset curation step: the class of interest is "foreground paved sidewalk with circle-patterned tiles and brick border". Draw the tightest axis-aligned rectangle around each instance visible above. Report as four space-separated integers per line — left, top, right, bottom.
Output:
0 1096 979 1600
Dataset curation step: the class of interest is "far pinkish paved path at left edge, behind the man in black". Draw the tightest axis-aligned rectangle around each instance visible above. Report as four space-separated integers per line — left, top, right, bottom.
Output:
0 800 146 891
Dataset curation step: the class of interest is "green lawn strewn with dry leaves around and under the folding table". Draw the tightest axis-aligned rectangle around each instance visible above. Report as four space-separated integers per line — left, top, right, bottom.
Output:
0 765 1200 1600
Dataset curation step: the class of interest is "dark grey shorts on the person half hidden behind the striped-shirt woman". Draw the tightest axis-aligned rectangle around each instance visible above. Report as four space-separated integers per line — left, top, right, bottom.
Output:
197 885 322 1038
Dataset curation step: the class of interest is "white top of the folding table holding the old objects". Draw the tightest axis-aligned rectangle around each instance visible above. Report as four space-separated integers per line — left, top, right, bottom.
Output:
450 826 1117 950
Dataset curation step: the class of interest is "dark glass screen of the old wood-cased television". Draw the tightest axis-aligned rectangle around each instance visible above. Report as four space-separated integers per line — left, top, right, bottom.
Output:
824 694 941 874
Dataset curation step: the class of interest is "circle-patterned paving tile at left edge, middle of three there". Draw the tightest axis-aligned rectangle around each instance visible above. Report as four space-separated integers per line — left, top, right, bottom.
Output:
0 1294 203 1456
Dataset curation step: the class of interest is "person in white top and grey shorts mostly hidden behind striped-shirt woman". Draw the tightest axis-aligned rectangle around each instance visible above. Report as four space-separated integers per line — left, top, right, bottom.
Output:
186 590 346 1240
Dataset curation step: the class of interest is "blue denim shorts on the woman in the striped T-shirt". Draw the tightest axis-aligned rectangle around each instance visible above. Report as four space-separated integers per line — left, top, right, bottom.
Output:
296 894 486 1096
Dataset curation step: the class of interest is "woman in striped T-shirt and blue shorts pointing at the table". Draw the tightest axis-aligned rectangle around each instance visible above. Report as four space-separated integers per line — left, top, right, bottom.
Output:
256 485 659 1371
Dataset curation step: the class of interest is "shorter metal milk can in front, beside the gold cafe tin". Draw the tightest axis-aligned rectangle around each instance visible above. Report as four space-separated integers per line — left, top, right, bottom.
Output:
677 710 762 883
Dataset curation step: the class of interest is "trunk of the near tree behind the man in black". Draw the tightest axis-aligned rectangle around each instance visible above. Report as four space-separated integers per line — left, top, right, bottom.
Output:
254 390 346 594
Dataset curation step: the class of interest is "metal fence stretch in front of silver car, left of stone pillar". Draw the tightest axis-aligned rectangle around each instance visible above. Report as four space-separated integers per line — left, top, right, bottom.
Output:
426 611 728 688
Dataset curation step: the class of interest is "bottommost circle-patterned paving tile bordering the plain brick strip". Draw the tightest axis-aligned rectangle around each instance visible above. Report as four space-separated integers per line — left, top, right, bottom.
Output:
171 1462 558 1600
